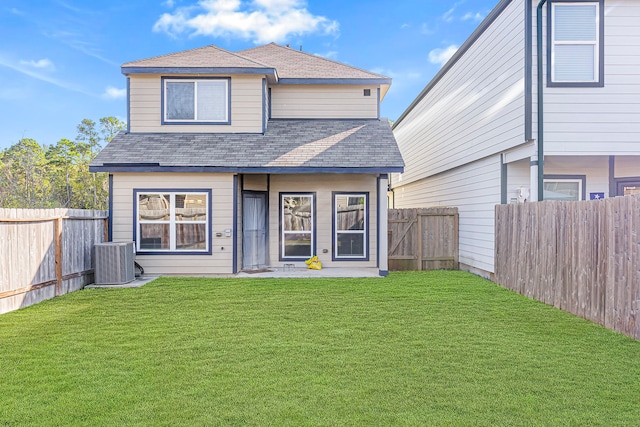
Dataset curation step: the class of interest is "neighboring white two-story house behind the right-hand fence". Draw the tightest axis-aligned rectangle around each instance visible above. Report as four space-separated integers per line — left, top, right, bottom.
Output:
390 0 640 277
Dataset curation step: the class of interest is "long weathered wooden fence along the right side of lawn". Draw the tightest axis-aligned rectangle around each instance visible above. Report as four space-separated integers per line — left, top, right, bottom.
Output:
495 195 640 339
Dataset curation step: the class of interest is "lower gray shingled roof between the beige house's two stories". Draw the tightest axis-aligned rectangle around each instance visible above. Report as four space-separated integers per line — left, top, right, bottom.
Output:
90 119 404 173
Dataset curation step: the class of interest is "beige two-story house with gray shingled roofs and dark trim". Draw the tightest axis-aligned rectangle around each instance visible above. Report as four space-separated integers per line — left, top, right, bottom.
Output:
90 43 404 275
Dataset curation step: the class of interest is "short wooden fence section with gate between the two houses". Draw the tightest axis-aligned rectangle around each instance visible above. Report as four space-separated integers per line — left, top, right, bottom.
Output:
388 208 459 271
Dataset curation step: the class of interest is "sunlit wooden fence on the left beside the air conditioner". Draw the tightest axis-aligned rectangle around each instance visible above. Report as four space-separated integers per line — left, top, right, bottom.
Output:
0 209 108 314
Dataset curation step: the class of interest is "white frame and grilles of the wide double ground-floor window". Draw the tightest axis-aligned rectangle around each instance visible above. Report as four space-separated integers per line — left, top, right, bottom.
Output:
135 190 211 253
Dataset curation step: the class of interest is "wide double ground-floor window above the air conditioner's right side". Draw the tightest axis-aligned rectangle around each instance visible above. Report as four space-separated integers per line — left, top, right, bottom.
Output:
134 190 211 253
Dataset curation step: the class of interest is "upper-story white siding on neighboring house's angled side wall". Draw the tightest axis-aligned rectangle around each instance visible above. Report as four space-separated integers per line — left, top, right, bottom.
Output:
393 2 524 187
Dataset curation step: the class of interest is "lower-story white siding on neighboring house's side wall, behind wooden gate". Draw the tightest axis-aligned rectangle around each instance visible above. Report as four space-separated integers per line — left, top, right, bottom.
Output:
393 155 500 273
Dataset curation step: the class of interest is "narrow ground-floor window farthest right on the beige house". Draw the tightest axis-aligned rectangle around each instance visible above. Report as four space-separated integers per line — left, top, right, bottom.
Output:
333 193 368 260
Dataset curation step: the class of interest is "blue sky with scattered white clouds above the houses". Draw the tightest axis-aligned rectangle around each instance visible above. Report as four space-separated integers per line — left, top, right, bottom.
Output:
0 0 497 149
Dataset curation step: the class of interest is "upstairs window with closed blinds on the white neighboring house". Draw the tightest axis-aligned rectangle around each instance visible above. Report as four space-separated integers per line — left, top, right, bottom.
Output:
548 1 603 86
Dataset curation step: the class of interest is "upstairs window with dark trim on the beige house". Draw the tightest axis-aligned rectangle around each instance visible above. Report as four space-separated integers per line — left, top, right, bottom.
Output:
162 78 229 124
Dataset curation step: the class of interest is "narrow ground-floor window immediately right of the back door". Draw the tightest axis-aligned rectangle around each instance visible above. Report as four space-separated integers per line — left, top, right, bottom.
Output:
280 193 315 260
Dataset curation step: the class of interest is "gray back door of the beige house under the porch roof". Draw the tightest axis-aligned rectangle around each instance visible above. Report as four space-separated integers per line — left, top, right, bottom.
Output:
242 191 269 270
